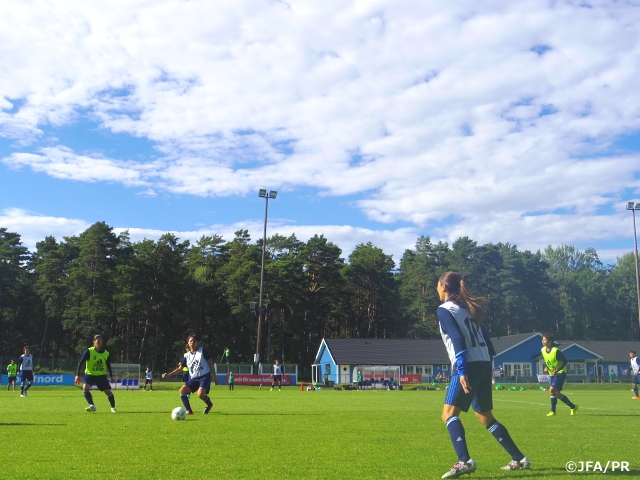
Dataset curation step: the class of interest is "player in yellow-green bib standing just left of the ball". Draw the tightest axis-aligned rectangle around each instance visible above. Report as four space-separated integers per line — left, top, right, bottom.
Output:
76 335 118 413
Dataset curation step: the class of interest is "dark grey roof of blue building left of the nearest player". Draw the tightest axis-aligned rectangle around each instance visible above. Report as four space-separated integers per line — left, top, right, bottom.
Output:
324 338 450 365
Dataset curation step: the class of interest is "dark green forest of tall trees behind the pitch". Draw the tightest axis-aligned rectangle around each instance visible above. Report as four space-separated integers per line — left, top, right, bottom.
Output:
0 222 640 375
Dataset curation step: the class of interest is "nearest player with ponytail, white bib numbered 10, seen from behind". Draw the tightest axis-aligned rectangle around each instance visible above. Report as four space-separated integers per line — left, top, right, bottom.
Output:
437 272 530 478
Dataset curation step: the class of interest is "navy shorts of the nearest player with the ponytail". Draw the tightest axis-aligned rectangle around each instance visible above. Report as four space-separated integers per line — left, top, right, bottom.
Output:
444 362 493 412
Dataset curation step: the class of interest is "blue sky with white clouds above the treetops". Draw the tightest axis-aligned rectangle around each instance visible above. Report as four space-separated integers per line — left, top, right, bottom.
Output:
0 0 640 262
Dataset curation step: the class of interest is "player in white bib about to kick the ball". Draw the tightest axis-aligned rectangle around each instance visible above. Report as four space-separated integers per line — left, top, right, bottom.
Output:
162 334 218 415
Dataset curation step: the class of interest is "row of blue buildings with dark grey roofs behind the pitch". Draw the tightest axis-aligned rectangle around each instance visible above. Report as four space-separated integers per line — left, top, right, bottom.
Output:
311 332 640 384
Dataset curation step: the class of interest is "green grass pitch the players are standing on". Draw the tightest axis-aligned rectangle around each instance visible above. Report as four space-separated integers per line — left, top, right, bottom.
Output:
0 383 640 479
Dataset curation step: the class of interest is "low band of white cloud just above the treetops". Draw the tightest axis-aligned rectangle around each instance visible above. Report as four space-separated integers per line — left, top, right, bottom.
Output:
0 208 631 267
